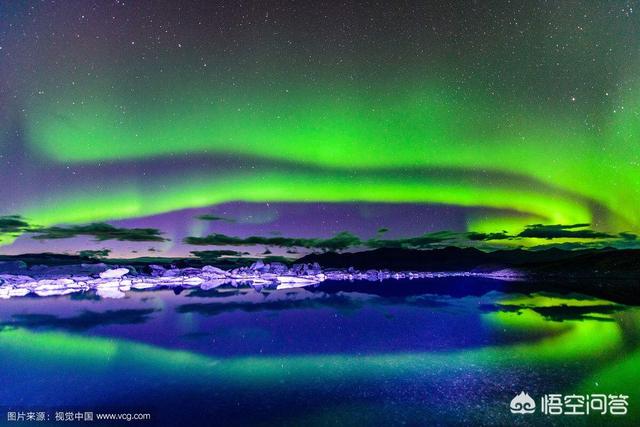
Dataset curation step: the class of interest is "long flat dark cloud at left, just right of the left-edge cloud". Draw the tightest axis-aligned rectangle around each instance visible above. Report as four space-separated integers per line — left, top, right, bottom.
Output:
28 223 167 242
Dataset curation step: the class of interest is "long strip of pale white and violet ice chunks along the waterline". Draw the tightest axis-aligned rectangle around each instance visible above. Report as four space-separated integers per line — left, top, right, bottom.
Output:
0 261 523 299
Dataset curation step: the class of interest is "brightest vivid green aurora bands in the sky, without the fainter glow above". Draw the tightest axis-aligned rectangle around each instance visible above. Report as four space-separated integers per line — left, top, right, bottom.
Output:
6 79 640 239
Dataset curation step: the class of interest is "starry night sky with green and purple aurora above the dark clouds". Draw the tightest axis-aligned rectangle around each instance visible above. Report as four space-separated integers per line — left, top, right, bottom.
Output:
0 0 640 256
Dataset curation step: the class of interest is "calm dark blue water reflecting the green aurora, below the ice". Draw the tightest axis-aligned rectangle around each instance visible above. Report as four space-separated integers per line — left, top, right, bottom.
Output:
0 278 640 425
